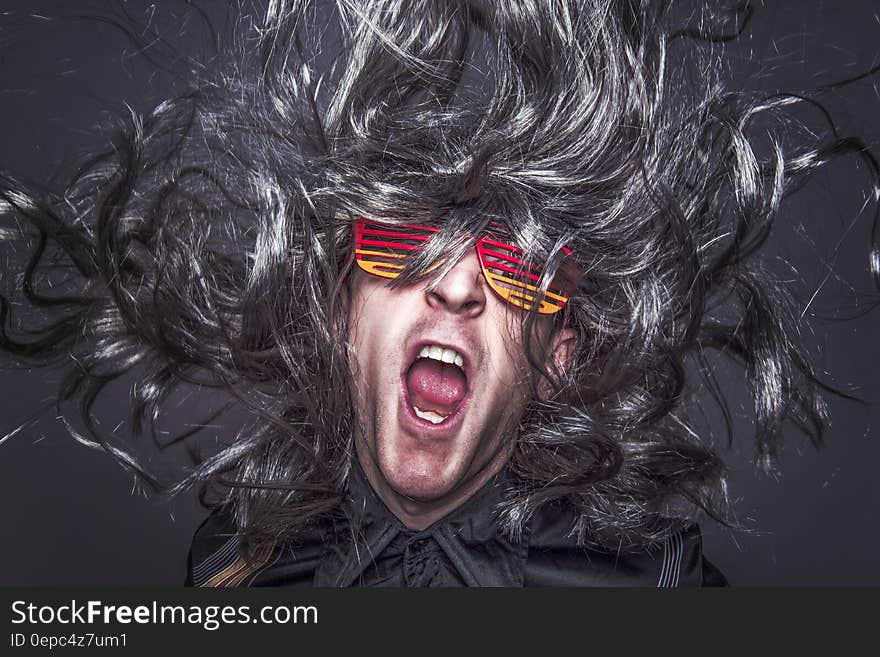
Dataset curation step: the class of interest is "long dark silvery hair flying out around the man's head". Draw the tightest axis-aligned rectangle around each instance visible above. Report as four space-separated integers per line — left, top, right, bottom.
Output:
0 0 880 550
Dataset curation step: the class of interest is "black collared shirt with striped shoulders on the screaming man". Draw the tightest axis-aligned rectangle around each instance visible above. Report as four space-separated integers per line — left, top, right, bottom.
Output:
187 462 727 587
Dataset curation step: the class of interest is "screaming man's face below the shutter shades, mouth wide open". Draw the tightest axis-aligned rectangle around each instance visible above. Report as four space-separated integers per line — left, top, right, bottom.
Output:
349 246 572 528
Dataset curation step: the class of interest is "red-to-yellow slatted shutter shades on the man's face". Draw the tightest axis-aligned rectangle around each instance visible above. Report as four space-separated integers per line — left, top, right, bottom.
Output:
354 219 571 315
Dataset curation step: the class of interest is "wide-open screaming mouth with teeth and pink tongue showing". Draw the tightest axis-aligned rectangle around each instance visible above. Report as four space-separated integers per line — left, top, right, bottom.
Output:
404 344 468 424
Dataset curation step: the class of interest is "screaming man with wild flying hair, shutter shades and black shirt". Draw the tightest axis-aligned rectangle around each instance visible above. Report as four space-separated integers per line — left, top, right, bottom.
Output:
0 0 876 586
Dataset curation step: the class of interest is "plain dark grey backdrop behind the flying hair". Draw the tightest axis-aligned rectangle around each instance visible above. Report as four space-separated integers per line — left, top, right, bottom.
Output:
0 0 880 585
